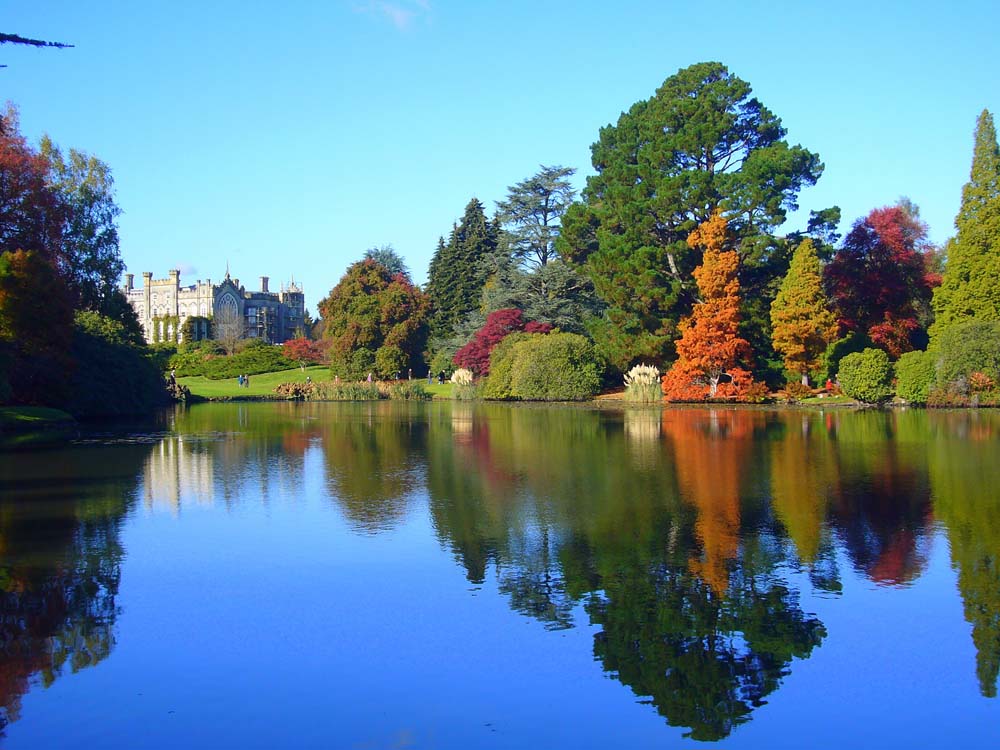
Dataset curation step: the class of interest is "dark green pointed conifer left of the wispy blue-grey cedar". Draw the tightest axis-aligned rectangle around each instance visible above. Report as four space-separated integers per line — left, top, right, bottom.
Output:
426 198 497 339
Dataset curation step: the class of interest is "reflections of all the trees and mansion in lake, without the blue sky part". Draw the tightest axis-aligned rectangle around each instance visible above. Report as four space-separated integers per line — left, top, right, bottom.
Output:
0 403 1000 740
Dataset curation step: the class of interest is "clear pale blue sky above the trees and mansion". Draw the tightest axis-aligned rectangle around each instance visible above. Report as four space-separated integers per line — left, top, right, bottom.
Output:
0 0 1000 312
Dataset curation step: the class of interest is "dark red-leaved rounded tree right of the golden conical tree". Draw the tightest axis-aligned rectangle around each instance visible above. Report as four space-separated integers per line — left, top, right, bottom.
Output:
824 206 933 358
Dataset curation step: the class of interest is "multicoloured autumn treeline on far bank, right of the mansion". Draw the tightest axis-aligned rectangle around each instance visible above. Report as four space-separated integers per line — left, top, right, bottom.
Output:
320 62 1000 403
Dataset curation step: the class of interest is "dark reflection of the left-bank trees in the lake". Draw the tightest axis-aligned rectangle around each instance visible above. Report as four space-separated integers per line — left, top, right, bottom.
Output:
0 445 148 729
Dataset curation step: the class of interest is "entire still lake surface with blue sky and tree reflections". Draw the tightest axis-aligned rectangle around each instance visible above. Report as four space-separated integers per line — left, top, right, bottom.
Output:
0 402 1000 748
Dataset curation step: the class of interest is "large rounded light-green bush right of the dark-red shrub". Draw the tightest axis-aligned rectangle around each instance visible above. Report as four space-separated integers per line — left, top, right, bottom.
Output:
510 333 601 401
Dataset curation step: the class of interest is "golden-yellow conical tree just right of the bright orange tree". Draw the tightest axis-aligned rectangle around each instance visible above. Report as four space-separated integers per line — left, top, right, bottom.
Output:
771 239 838 385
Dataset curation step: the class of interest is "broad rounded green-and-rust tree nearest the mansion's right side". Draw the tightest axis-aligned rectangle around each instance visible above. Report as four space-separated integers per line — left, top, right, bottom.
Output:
319 259 430 378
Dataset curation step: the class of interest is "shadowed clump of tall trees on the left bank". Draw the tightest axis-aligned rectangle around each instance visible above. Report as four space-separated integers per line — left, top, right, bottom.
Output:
0 106 166 417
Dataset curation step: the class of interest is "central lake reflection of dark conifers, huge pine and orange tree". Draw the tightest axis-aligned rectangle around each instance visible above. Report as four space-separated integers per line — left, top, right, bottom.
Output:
429 408 825 740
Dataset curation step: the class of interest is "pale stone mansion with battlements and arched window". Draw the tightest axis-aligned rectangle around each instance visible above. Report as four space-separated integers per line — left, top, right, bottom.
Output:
123 270 305 344
